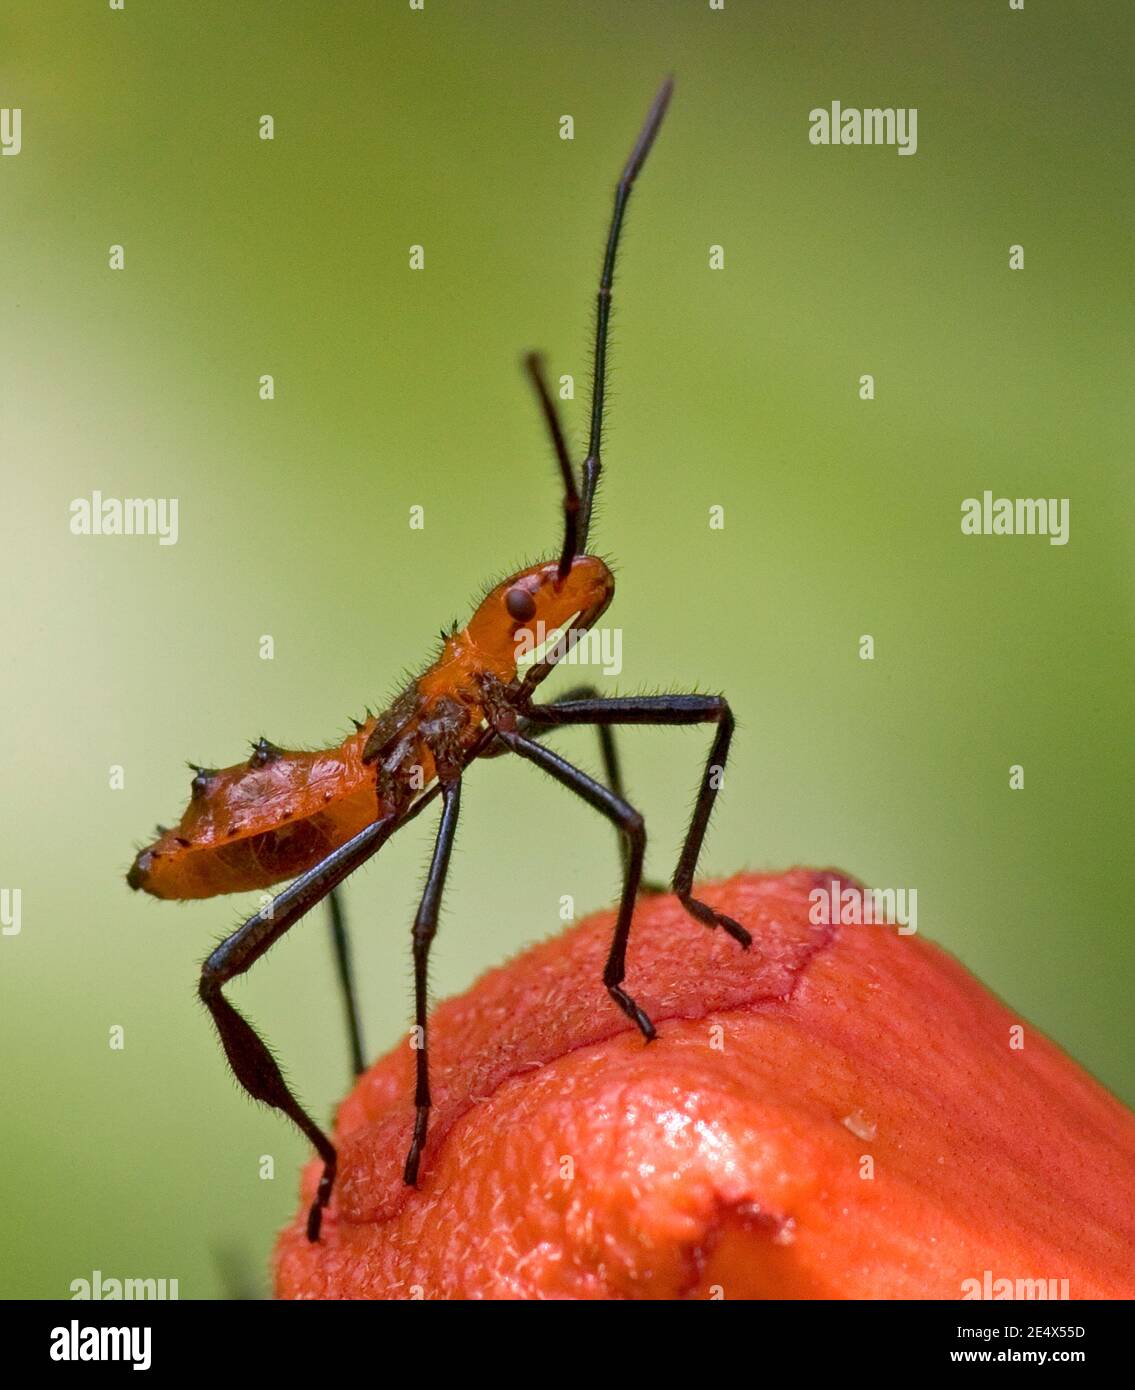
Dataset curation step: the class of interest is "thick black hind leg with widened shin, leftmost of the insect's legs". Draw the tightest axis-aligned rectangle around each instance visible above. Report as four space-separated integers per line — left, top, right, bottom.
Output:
197 790 436 1241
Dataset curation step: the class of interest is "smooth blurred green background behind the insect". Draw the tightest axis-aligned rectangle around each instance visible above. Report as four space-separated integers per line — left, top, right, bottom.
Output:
0 0 1135 1297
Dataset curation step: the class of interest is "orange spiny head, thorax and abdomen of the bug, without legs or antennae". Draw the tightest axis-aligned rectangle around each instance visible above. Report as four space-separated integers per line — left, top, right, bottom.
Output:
126 555 614 898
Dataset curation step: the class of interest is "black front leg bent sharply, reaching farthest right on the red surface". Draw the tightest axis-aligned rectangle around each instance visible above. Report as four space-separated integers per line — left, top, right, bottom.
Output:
528 695 753 949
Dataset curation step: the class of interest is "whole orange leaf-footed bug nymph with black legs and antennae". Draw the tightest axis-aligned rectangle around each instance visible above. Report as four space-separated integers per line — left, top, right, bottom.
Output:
128 82 750 1241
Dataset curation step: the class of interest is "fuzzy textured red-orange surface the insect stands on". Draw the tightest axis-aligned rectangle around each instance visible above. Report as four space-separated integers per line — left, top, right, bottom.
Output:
276 869 1135 1298
